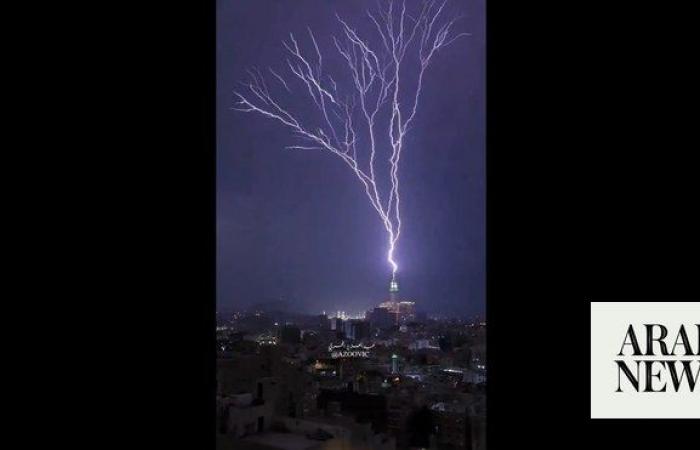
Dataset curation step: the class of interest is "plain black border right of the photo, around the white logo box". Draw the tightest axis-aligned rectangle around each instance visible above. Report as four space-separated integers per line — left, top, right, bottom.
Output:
487 1 700 449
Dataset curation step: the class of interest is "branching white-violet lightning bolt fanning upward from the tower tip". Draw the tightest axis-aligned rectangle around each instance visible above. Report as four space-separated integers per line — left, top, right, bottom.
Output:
234 0 467 280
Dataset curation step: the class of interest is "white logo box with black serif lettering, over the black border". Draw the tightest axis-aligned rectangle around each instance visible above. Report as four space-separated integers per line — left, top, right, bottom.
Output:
591 302 700 419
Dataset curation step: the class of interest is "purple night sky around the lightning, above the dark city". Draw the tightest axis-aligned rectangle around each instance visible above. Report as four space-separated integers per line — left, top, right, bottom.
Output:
217 0 486 314
